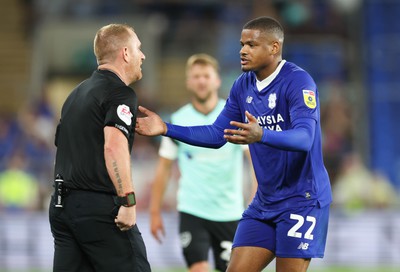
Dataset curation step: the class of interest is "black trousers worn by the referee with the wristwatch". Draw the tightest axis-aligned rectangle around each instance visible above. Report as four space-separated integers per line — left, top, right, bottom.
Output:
49 190 151 272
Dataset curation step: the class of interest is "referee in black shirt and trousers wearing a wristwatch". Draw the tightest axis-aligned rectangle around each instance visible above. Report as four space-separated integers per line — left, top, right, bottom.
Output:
49 24 151 272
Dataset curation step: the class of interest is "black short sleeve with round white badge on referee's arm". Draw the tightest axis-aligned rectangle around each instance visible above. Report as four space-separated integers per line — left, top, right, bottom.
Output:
103 86 137 141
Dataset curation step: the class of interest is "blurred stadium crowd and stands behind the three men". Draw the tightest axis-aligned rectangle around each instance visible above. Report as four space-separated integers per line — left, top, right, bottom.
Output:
0 0 400 270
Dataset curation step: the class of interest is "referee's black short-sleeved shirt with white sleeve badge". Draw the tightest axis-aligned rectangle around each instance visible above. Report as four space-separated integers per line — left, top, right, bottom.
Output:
54 70 137 194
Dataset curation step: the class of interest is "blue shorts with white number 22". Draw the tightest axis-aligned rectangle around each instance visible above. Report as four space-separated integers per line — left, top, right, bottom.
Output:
233 205 329 258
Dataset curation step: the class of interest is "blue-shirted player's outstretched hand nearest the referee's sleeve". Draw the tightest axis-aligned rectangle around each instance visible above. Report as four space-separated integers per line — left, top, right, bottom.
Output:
135 106 167 136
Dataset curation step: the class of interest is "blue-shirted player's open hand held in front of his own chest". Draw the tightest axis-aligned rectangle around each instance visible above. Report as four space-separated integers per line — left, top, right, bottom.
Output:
224 111 263 144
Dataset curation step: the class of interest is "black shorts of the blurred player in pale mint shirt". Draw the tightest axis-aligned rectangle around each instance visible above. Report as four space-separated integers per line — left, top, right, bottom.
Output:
179 212 239 271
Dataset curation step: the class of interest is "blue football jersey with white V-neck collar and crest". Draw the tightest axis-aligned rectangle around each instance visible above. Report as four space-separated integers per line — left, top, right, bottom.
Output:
224 61 332 210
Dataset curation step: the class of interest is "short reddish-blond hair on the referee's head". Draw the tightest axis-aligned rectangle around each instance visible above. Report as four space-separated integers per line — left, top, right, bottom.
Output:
93 24 134 65
